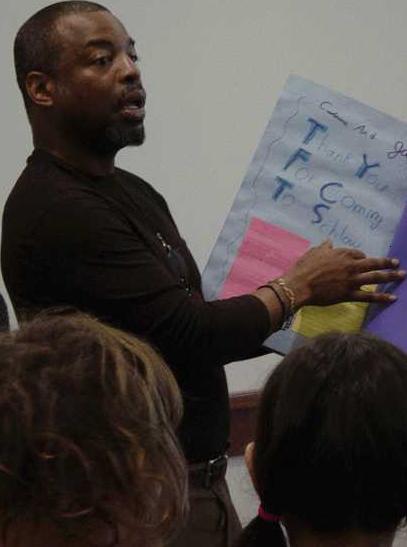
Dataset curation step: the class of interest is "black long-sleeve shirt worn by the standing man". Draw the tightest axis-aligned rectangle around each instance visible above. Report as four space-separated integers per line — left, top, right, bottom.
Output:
1 150 270 461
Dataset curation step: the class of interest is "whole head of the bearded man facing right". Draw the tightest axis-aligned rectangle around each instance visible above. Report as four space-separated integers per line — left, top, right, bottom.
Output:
14 1 146 161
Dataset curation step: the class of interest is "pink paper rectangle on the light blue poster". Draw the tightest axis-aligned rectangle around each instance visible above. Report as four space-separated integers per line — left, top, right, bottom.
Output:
220 217 310 298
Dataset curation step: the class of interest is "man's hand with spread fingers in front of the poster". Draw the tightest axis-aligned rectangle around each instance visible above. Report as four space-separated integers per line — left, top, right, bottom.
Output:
283 241 406 308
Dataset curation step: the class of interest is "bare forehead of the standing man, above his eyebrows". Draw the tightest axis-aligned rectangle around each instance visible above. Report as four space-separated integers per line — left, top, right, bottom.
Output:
56 11 129 47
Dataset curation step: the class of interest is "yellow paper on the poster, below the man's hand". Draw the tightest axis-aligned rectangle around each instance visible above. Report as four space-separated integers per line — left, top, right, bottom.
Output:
292 285 376 338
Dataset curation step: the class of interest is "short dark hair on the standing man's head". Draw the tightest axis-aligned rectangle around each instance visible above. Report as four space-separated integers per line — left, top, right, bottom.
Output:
14 0 109 108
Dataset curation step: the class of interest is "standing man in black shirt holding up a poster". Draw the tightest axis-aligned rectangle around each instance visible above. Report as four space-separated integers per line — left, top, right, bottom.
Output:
2 2 404 547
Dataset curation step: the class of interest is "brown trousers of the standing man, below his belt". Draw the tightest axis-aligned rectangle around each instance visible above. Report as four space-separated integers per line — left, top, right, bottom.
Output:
171 476 242 547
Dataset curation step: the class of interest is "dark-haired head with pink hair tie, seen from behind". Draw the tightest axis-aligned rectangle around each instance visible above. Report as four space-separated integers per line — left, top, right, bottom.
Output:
239 334 407 547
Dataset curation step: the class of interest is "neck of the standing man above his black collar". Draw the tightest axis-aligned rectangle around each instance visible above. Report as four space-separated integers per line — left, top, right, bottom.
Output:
34 133 116 176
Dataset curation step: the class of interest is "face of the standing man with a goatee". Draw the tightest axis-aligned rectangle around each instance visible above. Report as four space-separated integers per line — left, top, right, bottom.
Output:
53 11 146 153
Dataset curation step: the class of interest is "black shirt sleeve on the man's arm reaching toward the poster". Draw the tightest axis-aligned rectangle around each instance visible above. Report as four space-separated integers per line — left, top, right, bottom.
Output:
32 195 270 365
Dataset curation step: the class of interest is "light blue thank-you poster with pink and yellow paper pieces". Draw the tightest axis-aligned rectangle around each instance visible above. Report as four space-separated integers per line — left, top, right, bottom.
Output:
203 75 407 354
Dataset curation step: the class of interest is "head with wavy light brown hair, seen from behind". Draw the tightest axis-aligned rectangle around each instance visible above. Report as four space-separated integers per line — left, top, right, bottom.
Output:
0 313 186 547
